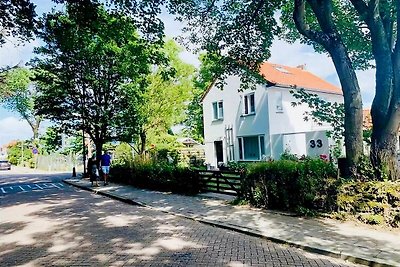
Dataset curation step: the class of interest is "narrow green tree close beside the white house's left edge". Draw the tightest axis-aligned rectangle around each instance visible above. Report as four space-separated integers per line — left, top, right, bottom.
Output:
185 54 218 142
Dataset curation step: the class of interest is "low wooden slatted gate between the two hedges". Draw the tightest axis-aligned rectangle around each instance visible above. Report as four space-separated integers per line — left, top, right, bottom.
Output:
198 170 242 196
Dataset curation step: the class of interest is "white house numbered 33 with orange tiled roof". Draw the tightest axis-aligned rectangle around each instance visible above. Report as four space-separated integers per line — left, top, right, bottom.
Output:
202 63 343 166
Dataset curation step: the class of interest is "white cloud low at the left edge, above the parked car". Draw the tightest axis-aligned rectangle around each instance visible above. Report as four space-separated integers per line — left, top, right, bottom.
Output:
0 117 33 144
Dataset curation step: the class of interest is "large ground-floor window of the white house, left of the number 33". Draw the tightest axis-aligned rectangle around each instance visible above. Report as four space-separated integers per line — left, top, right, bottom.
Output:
238 135 265 160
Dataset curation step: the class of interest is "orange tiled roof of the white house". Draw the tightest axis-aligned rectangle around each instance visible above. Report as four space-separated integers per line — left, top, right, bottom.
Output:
260 62 343 94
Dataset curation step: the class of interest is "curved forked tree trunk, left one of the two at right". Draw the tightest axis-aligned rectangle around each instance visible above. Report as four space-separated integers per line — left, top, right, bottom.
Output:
293 0 363 175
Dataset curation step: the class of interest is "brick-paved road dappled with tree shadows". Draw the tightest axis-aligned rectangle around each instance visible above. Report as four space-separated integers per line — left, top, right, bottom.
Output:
0 173 354 266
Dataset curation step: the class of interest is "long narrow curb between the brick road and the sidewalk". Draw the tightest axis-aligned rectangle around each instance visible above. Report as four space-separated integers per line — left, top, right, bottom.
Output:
62 179 396 267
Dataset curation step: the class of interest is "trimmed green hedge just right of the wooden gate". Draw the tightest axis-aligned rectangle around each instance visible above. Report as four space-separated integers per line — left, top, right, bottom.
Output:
243 159 341 213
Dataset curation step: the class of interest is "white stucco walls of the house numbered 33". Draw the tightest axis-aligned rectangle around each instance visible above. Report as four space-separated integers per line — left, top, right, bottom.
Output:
203 76 343 166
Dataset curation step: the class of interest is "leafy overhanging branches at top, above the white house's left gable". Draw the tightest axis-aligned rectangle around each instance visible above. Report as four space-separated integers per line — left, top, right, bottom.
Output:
168 0 282 89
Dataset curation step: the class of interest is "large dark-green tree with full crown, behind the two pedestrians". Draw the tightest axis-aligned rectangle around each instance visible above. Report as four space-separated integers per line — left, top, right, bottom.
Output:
32 2 161 162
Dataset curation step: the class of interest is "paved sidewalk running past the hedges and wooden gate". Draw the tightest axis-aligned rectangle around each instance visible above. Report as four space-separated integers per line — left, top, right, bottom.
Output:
64 179 400 266
